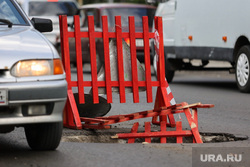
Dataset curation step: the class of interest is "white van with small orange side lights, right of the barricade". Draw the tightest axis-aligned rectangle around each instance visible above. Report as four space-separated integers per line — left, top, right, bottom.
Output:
156 0 250 92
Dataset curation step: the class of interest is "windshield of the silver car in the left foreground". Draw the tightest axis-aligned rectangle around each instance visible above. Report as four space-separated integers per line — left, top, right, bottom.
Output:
0 0 26 25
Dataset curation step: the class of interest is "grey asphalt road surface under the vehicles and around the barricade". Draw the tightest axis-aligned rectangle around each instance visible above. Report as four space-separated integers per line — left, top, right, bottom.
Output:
0 67 250 167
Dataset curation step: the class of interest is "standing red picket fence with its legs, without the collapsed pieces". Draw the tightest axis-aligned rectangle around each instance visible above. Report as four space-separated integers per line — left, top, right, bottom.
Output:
59 15 175 129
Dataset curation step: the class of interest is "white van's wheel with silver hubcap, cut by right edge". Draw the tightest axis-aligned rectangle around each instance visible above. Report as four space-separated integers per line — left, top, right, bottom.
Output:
235 45 250 93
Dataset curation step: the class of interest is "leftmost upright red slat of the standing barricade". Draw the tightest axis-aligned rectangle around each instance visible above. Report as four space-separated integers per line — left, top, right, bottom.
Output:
60 15 72 90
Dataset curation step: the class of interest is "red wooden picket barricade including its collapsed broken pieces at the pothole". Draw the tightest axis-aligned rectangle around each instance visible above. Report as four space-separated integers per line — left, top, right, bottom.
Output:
59 16 213 143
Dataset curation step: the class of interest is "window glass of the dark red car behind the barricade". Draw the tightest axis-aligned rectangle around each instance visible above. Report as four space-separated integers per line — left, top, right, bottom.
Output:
104 8 155 27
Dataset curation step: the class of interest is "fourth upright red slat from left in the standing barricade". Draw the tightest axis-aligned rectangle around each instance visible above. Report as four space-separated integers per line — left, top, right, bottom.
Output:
102 16 112 103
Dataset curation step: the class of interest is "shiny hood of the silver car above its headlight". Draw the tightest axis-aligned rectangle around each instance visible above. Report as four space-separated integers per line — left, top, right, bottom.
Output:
0 26 55 69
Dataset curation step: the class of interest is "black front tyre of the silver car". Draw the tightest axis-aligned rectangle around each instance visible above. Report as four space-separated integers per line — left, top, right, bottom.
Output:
25 122 63 150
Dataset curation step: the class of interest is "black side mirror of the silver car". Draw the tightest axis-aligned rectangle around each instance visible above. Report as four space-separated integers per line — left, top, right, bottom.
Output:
31 18 53 32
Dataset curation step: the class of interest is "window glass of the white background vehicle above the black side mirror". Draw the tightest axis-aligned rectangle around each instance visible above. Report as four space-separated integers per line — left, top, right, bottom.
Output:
29 1 77 16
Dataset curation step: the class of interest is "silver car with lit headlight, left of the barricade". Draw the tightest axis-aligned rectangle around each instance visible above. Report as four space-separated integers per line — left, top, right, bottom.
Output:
0 0 67 150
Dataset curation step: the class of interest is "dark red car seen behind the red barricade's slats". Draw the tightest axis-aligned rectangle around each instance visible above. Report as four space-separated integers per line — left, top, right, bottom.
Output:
58 3 156 68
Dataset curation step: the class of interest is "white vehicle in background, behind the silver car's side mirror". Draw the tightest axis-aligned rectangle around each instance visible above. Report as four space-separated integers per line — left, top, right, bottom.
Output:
17 0 79 45
